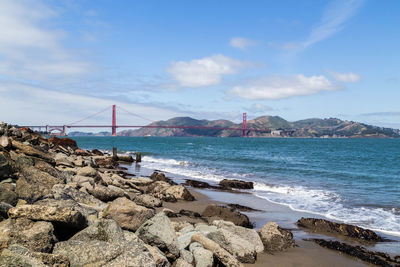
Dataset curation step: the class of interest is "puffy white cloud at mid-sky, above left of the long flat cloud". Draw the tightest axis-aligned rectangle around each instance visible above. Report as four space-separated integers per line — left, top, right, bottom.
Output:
167 54 251 87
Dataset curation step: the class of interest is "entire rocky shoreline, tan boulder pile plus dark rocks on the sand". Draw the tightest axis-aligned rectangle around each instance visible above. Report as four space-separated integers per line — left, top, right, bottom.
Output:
0 123 400 267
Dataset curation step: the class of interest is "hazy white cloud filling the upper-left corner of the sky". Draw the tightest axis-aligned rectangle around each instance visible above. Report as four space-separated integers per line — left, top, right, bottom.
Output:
0 0 91 81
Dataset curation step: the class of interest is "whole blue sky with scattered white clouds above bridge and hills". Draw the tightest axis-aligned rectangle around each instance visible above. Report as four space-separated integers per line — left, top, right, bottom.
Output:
0 0 400 128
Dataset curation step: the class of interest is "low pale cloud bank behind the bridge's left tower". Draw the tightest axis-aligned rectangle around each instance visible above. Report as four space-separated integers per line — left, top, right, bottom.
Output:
0 82 184 126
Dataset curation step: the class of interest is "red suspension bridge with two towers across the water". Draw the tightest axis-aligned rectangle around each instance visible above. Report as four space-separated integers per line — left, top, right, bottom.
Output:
24 105 271 137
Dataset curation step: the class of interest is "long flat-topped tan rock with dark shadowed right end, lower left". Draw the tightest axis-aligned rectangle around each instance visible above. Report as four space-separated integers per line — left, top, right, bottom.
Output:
8 205 87 229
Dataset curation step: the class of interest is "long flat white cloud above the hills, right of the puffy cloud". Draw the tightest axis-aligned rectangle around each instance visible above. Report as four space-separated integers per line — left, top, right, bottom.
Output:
227 74 342 100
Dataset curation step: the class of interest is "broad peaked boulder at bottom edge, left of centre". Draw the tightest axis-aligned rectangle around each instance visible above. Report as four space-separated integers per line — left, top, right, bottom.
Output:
53 220 156 267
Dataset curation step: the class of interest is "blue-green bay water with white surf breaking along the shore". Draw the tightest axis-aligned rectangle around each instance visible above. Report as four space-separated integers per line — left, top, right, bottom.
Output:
74 137 400 235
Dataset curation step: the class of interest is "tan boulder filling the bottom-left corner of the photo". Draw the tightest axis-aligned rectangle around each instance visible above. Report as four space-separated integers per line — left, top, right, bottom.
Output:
0 244 69 267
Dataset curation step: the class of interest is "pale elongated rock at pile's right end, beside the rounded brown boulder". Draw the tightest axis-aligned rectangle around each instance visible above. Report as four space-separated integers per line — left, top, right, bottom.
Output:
213 220 264 253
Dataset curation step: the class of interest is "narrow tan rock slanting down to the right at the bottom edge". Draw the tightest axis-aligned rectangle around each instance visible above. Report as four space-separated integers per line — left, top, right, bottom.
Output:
192 233 244 267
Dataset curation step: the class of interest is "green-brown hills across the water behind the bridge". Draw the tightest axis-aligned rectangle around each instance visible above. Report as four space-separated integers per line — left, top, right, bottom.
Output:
118 116 400 138
